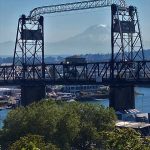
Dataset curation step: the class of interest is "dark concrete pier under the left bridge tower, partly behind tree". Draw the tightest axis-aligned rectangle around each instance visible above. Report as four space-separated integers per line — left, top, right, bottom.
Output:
21 84 46 106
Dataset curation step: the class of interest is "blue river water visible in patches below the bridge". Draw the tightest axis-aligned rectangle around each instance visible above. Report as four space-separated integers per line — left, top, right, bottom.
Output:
0 87 150 128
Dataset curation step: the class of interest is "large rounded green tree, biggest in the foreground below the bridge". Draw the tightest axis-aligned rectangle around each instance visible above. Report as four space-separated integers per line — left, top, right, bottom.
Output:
0 100 116 150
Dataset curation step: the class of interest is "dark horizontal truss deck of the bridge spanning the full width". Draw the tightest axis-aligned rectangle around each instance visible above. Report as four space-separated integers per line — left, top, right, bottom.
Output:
0 61 150 86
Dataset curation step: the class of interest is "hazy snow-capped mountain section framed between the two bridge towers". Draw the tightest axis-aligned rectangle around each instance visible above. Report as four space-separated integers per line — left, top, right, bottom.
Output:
46 25 110 55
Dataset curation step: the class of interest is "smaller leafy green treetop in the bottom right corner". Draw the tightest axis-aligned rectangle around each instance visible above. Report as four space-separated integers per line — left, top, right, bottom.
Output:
99 128 150 150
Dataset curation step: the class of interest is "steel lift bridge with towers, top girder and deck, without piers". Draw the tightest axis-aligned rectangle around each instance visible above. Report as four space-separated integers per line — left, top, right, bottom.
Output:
0 0 150 85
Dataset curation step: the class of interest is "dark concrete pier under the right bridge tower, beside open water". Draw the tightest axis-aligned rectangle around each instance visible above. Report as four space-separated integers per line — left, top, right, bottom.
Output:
109 85 135 111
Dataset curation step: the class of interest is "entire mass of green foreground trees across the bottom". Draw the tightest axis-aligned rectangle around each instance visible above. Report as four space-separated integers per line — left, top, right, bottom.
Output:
0 100 150 150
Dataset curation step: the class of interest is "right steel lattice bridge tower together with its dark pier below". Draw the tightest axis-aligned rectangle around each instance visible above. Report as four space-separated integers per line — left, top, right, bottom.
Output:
109 4 144 111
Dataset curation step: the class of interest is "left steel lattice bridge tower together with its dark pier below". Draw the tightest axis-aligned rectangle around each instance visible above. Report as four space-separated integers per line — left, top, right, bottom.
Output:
13 15 45 106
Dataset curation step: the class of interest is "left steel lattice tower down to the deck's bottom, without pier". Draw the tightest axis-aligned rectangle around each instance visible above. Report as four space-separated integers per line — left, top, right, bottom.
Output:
13 15 45 79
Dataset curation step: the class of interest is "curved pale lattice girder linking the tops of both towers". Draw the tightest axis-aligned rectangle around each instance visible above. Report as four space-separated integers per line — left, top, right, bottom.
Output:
29 0 122 18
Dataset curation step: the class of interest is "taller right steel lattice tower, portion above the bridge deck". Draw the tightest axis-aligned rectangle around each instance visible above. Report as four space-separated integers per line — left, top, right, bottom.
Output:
111 4 144 62
